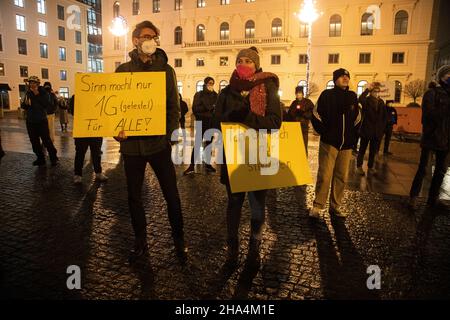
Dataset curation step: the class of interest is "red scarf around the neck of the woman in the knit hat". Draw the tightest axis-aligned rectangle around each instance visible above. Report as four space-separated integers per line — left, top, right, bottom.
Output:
230 70 279 116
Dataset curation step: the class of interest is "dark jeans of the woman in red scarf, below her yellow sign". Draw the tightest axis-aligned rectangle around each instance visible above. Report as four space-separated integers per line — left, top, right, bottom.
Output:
226 183 267 243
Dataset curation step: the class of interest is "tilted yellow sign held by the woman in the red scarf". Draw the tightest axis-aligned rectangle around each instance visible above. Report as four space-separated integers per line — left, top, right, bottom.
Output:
222 122 312 193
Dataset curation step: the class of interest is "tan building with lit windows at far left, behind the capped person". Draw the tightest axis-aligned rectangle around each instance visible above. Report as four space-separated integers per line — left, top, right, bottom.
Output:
0 0 88 110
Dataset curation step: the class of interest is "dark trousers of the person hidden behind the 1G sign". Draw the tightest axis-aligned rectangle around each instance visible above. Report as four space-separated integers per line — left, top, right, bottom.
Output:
75 138 103 176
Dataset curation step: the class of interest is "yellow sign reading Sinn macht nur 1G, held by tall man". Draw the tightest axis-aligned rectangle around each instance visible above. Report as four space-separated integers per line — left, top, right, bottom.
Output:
73 72 166 138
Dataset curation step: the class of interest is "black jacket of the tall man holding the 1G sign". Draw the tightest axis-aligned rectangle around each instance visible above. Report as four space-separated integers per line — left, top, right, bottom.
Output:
116 48 180 156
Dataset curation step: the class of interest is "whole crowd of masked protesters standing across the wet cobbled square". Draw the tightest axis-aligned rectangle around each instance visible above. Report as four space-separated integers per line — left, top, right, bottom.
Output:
0 21 450 265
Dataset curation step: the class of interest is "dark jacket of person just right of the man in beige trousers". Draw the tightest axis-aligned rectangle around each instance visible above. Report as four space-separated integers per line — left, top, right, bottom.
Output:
359 89 387 140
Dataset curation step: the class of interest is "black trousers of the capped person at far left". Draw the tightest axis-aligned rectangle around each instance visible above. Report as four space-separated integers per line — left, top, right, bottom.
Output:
27 119 57 161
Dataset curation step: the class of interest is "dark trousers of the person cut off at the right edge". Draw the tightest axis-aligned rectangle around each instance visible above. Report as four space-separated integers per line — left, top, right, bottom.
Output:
409 148 448 203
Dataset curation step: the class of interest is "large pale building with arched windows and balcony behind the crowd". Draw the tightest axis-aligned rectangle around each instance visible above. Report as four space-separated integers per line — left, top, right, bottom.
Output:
102 0 436 104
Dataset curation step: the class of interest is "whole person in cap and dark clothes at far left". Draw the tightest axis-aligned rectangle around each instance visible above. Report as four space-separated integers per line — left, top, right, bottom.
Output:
21 76 58 166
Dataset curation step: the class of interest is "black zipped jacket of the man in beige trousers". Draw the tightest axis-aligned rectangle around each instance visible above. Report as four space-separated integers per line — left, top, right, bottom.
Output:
311 86 361 150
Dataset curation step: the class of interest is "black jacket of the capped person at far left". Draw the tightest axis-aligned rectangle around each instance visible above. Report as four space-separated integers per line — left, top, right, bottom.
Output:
21 86 53 123
